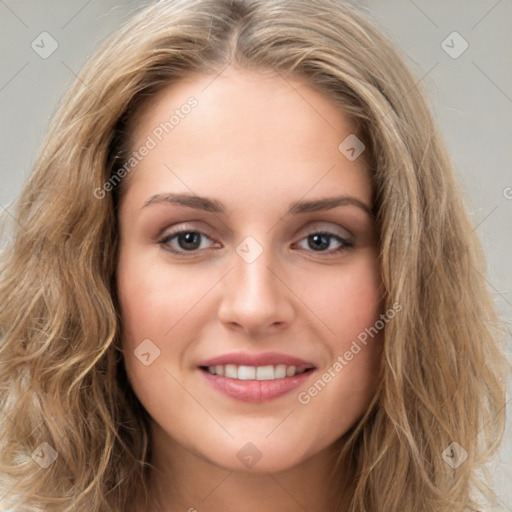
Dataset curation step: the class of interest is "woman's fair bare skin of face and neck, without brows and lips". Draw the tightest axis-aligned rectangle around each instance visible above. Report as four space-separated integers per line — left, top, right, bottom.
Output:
117 67 382 512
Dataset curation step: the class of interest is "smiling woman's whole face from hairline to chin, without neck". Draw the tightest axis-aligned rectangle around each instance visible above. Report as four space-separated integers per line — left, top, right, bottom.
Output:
117 68 382 471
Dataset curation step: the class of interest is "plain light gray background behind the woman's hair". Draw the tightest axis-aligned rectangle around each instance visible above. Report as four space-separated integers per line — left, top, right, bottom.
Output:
0 0 512 512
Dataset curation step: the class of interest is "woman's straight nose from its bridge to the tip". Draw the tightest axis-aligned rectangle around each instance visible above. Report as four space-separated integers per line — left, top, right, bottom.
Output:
219 236 293 331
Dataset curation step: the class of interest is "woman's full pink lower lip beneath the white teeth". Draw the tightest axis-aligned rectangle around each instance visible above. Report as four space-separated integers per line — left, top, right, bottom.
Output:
199 370 314 402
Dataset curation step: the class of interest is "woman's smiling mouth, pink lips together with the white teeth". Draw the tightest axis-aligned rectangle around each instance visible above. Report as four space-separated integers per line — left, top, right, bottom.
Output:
198 353 316 402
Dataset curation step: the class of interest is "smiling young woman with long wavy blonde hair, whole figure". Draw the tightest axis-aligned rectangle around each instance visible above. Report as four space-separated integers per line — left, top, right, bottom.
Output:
0 0 506 512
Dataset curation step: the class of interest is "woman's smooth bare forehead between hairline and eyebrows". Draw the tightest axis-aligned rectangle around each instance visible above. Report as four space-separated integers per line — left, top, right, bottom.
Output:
120 68 371 212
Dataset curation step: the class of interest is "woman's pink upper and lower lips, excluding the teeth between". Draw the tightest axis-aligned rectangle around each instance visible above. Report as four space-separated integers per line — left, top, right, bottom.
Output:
197 352 316 402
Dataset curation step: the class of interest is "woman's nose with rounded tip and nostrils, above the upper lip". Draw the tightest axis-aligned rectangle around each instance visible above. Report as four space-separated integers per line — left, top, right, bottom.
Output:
218 240 295 336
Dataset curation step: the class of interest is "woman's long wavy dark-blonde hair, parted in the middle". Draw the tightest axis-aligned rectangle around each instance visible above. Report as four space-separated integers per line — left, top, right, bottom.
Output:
0 0 508 512
